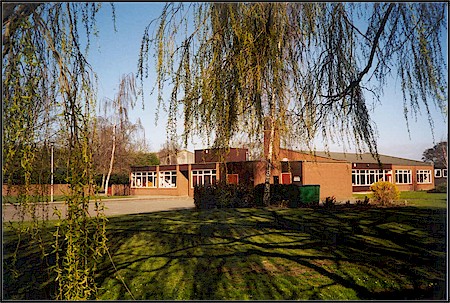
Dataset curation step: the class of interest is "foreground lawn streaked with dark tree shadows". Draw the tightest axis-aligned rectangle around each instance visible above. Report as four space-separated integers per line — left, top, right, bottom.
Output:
3 194 447 300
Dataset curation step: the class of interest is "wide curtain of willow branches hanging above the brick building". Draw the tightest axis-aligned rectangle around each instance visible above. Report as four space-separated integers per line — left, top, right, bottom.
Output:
138 3 447 155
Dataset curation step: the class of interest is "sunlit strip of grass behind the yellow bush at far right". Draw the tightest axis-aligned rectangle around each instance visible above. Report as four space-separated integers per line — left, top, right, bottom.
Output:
353 191 447 208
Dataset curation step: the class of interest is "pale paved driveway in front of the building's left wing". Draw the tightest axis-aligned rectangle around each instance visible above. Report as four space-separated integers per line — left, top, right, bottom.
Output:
2 196 194 222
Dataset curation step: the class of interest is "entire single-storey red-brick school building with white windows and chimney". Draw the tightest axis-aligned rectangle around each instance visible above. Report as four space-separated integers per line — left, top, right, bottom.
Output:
130 123 435 200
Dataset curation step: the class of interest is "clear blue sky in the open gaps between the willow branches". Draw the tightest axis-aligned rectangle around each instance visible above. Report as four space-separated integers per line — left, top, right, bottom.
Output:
84 2 448 160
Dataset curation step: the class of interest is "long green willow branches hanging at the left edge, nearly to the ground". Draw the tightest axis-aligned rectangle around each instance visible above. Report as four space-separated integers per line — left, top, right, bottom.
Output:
2 3 115 300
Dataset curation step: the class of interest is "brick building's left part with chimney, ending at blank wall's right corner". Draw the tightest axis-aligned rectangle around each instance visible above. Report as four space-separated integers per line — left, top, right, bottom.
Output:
130 122 352 199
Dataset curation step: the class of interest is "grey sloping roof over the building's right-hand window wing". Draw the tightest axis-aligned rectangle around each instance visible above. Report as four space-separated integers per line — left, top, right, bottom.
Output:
315 152 433 166
